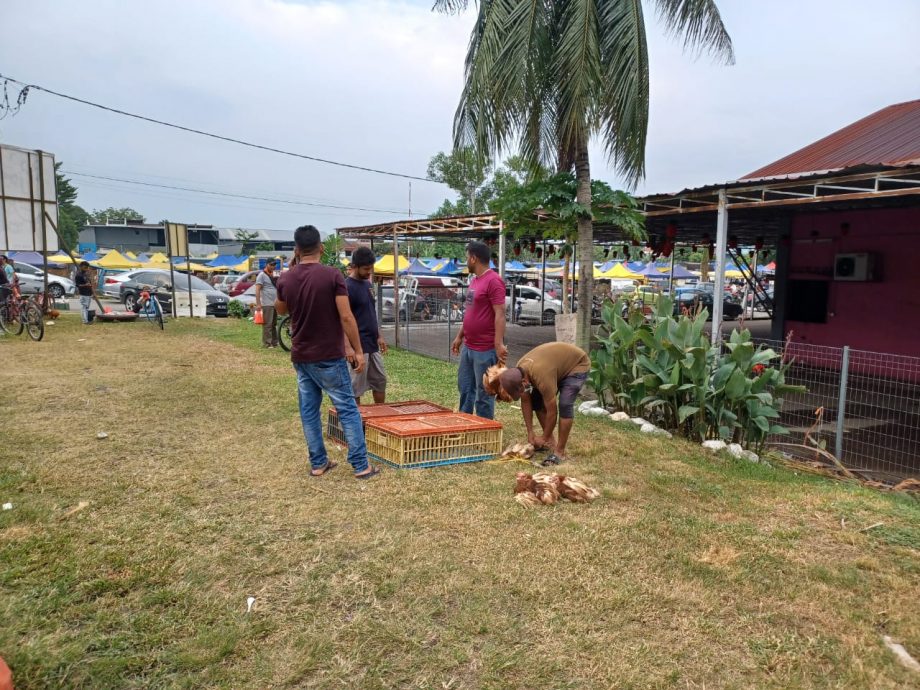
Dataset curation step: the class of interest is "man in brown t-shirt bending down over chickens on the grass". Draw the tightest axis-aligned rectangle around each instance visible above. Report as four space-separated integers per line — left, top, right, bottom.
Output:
498 343 591 465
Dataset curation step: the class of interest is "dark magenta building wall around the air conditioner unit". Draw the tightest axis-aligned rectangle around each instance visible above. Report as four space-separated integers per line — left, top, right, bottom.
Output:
785 203 920 357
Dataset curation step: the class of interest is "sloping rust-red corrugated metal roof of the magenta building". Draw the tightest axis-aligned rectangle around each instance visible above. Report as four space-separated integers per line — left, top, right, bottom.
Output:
742 100 920 180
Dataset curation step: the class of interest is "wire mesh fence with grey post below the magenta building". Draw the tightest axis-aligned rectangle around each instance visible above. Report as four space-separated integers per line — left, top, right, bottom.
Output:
759 340 920 477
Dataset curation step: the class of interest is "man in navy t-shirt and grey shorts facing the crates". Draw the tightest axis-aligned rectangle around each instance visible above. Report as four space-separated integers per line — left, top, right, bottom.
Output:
345 247 387 404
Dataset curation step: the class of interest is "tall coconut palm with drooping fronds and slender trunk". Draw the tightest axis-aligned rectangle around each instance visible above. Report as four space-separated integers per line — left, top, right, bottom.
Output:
434 0 734 349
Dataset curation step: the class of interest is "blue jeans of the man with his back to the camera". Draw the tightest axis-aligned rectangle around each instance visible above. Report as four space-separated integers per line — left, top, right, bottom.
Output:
294 359 367 474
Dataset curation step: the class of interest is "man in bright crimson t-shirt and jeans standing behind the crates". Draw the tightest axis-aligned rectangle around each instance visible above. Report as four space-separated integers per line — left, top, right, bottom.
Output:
451 242 508 419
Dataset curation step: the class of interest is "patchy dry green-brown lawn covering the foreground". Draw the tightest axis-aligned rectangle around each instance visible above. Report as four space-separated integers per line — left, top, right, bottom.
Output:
0 315 920 690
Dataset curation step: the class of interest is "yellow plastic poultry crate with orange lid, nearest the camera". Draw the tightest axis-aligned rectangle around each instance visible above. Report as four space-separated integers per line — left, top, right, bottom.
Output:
364 412 502 468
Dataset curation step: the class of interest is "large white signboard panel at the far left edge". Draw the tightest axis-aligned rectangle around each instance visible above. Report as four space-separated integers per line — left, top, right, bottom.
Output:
0 145 59 252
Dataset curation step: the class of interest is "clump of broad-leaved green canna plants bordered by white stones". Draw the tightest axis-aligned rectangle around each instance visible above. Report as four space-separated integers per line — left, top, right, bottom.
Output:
590 297 805 451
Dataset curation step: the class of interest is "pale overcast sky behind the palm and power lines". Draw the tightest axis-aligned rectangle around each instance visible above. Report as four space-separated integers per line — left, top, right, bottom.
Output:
0 0 920 231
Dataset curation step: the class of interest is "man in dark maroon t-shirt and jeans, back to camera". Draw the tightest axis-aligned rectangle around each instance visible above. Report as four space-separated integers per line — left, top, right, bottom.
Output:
275 225 380 479
